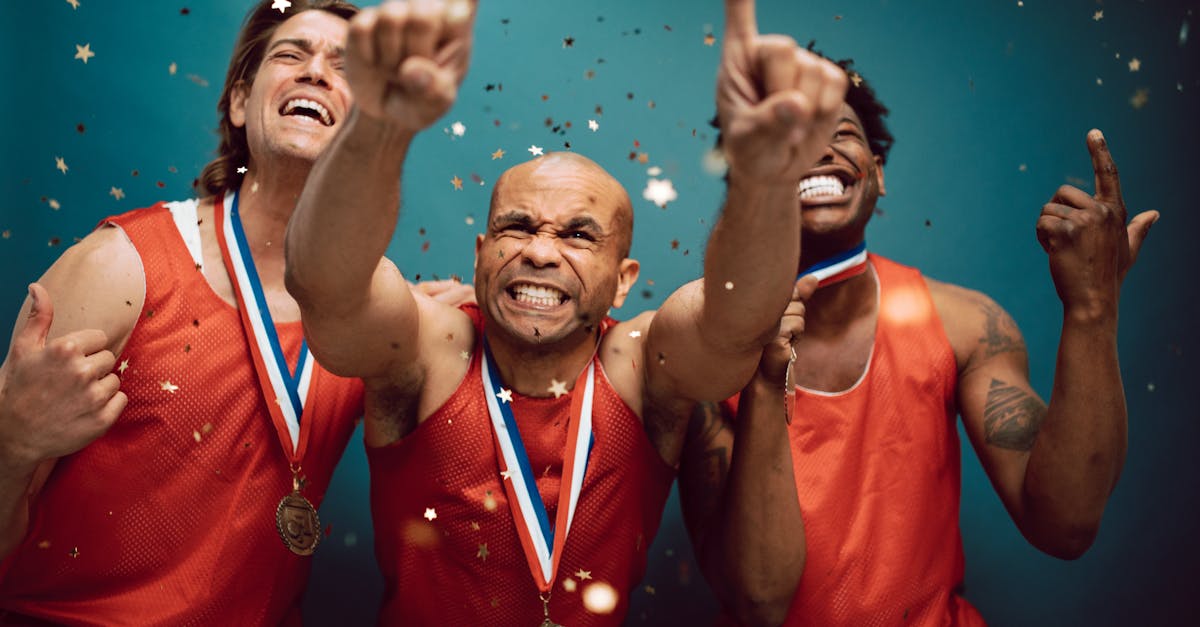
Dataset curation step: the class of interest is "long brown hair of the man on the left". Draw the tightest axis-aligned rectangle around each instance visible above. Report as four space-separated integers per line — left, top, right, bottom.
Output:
194 0 359 197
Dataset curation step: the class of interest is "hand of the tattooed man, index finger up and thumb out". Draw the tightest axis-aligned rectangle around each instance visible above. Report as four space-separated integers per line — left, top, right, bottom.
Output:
1037 129 1159 315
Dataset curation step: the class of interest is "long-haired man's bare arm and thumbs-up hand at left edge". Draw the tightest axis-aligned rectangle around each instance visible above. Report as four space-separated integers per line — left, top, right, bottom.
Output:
0 228 145 557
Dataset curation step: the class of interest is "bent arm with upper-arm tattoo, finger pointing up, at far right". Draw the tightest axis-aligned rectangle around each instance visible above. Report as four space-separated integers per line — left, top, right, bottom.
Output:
943 130 1158 559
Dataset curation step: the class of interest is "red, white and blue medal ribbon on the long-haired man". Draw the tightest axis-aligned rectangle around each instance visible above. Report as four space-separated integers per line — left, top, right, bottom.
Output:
216 187 313 462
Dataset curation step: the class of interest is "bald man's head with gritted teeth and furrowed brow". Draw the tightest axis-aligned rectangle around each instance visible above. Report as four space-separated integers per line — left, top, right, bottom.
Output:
475 153 638 345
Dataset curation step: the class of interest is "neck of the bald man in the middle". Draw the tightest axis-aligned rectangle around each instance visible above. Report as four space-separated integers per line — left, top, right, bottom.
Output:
487 321 598 396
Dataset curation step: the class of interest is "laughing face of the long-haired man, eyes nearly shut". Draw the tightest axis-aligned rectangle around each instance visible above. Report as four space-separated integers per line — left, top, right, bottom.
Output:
229 11 353 168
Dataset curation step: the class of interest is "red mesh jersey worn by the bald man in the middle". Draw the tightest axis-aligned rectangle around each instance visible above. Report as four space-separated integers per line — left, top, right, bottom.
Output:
367 305 674 627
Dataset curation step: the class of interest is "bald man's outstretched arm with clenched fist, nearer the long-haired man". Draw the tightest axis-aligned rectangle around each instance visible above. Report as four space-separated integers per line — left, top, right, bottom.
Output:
287 0 474 378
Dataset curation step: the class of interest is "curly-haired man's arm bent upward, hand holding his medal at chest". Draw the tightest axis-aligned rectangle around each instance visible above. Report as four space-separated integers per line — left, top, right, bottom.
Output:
679 276 817 626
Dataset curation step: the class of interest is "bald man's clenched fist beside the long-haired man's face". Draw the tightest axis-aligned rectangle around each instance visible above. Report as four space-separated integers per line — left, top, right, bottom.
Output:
346 0 476 132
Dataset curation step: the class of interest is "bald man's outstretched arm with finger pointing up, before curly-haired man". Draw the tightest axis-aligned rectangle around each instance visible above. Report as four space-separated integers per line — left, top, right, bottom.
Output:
646 0 847 400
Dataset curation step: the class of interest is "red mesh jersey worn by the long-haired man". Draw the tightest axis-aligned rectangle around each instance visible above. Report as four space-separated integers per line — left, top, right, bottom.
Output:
0 204 362 625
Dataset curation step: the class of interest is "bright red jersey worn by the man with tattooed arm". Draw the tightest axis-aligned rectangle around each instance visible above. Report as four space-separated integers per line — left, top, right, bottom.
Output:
720 255 984 627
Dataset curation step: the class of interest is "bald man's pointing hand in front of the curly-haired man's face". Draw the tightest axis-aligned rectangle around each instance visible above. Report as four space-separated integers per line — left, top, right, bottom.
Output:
716 0 848 185
